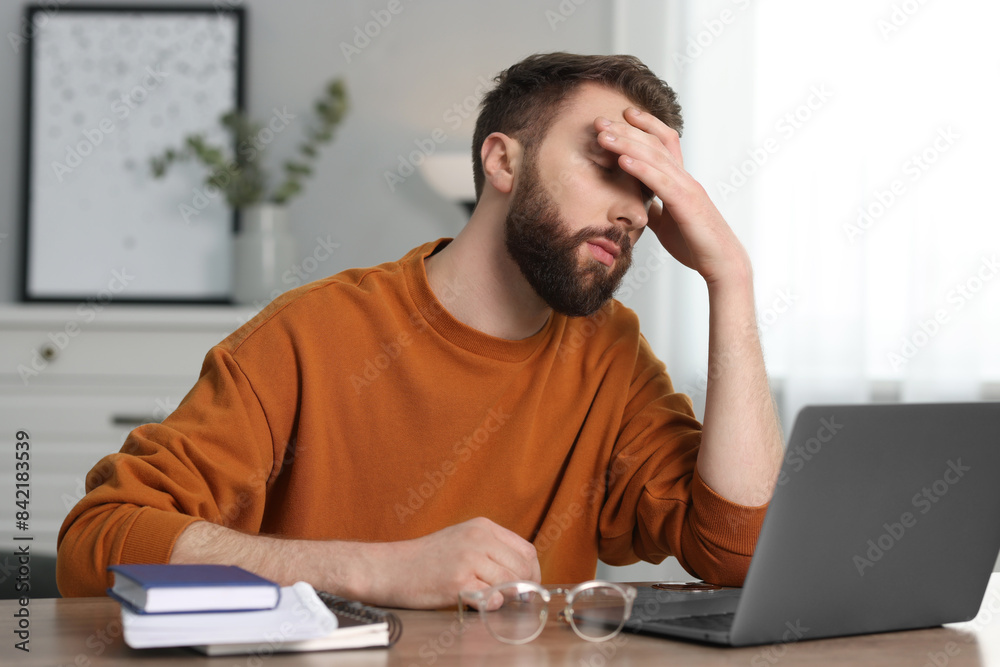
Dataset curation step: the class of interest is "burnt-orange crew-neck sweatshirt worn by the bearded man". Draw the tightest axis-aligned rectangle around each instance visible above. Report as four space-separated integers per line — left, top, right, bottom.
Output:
58 240 765 595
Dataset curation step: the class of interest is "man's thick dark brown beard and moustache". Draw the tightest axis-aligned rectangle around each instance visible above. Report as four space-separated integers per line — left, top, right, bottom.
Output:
504 156 632 317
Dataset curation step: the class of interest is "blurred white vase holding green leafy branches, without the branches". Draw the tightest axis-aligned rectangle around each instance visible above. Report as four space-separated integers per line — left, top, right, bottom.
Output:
233 204 295 307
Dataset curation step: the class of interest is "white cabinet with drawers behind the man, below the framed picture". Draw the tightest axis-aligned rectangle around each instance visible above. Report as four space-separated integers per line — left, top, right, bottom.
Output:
0 304 253 566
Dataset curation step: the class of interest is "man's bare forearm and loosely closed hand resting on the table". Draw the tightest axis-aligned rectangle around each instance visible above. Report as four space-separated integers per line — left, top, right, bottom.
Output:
170 517 541 609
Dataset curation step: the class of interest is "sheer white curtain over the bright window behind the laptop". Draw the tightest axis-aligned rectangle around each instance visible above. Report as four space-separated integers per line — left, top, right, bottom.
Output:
616 0 1000 431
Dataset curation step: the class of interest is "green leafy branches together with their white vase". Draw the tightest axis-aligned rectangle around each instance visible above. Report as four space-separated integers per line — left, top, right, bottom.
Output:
150 78 348 304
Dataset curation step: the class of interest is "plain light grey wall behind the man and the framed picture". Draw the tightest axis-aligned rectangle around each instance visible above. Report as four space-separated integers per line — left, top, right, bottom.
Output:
0 0 612 302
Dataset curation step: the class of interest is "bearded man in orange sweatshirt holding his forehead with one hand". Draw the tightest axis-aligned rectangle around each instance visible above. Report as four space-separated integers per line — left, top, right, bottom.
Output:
59 53 782 608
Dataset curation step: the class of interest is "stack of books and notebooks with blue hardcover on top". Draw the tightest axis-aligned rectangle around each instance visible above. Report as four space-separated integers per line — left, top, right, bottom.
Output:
108 565 402 655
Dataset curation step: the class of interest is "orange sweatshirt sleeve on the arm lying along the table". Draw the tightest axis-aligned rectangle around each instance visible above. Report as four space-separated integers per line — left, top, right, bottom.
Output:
56 346 280 596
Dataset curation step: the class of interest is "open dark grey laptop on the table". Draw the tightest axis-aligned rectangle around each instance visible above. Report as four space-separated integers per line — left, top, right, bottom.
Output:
584 402 1000 646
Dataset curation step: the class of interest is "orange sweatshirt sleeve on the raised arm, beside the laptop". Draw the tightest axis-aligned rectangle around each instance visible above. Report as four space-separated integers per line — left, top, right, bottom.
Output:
600 336 767 586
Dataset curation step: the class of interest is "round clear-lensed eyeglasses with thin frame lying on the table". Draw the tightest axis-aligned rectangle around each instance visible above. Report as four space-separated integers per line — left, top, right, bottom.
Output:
458 581 636 644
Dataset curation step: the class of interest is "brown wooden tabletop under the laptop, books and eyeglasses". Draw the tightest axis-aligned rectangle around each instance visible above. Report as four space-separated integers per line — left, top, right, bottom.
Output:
0 575 1000 667
